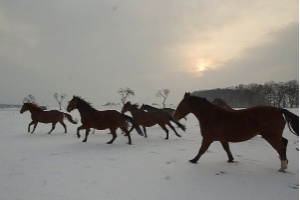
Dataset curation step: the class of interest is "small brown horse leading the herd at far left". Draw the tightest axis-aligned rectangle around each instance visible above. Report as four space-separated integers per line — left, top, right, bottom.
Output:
20 103 77 134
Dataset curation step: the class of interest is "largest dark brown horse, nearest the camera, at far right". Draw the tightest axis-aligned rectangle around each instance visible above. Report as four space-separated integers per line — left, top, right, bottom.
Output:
174 93 299 172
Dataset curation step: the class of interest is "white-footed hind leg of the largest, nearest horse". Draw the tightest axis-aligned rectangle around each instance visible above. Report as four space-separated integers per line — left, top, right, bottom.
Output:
264 134 288 172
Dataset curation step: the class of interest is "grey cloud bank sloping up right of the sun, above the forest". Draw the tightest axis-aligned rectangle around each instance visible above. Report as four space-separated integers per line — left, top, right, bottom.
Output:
199 23 299 87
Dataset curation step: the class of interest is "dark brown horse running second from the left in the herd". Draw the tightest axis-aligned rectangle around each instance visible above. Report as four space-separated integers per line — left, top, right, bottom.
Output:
67 96 143 144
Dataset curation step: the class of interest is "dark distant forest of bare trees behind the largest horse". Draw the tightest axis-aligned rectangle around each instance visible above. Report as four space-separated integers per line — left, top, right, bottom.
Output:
193 80 299 108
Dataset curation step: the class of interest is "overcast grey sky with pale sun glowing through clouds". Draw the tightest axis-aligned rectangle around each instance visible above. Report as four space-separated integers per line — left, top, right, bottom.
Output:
0 0 299 106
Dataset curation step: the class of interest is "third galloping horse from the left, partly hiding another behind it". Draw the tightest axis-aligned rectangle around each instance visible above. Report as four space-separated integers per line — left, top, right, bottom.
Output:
121 101 185 140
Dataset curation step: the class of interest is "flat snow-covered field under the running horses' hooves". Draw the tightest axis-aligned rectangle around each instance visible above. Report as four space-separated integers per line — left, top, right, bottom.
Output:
0 107 299 200
